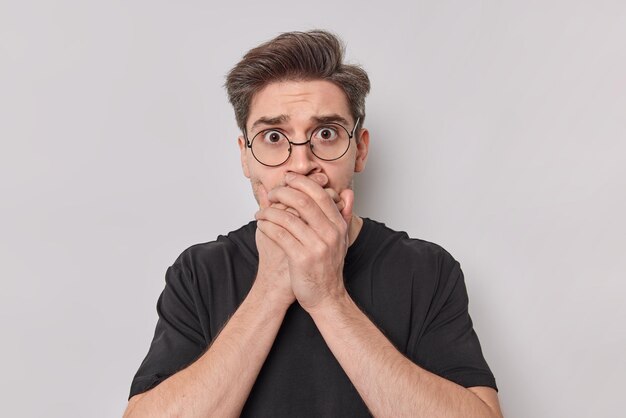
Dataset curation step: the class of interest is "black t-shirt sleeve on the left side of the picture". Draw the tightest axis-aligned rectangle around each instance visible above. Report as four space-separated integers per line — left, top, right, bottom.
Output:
129 260 208 399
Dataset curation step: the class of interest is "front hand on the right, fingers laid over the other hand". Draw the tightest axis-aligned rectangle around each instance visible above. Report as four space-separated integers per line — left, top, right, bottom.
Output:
256 173 354 310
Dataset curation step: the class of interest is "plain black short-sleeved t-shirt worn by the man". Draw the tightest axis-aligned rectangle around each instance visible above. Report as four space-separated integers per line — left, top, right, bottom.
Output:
130 218 497 417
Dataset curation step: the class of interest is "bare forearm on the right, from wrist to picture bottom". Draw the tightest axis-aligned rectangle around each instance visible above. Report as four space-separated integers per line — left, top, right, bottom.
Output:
309 295 500 418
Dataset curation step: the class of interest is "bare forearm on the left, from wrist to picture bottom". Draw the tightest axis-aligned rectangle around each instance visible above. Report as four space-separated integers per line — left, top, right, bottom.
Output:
124 286 288 417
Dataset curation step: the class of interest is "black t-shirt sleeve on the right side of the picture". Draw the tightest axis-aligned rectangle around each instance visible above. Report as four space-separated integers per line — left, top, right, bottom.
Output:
414 259 498 390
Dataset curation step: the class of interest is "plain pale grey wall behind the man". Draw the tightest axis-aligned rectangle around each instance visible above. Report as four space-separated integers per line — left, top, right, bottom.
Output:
0 0 626 418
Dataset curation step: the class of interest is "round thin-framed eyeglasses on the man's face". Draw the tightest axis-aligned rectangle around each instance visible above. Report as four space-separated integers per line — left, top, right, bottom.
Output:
244 118 361 167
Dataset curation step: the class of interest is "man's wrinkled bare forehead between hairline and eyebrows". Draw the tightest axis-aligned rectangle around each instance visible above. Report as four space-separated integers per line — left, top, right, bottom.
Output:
247 80 352 127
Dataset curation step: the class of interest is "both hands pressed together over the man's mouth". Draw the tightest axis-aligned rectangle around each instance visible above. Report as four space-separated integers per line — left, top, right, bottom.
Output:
255 173 354 311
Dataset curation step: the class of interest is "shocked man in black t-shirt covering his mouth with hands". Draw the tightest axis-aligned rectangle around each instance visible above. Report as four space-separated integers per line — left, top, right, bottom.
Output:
126 31 501 417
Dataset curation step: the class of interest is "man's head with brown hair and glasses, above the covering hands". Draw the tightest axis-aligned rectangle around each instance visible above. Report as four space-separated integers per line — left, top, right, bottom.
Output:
226 31 369 207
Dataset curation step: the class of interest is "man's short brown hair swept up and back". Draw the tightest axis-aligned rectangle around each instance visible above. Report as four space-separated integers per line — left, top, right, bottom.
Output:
225 30 370 133
